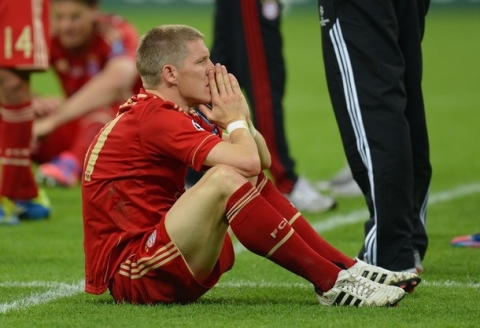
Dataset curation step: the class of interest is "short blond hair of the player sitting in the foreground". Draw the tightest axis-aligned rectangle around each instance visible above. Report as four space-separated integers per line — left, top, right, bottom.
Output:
136 25 204 88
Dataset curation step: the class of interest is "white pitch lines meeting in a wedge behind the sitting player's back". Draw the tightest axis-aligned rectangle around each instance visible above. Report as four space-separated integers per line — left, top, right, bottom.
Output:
0 280 84 313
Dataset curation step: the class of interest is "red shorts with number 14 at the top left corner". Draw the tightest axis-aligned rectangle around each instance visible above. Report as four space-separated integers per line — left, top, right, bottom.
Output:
0 0 50 70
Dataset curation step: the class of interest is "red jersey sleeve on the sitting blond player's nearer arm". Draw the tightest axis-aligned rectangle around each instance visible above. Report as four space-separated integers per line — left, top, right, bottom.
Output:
140 105 222 171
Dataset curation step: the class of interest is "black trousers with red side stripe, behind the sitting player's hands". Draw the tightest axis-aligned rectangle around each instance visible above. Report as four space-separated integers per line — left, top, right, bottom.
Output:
211 0 298 193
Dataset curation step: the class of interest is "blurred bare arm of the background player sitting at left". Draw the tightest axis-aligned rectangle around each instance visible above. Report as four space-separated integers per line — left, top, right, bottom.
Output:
34 56 137 137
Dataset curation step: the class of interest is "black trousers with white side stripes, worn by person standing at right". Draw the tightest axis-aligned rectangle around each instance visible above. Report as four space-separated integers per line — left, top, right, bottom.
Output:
318 0 432 270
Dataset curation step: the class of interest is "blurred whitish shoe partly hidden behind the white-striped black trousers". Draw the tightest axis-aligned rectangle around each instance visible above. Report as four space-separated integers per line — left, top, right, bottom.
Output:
315 165 362 197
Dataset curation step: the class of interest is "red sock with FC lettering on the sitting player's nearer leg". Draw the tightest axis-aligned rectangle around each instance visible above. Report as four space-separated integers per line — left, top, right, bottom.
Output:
227 182 340 291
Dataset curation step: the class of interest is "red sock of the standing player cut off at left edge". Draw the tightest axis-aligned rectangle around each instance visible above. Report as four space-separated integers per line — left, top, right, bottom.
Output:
0 102 38 199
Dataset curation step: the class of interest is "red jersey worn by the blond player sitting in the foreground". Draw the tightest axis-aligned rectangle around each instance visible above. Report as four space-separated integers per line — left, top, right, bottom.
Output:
82 90 221 294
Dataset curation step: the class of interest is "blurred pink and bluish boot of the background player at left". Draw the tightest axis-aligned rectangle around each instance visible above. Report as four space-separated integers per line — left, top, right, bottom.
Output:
37 152 81 187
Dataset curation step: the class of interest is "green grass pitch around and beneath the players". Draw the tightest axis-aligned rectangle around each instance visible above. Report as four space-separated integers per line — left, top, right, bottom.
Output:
0 6 480 327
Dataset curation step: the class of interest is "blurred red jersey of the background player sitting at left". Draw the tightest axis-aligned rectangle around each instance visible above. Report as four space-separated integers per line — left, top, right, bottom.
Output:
51 15 141 97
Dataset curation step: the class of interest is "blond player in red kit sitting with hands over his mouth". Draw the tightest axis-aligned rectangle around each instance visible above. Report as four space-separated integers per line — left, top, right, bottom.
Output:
82 25 420 306
